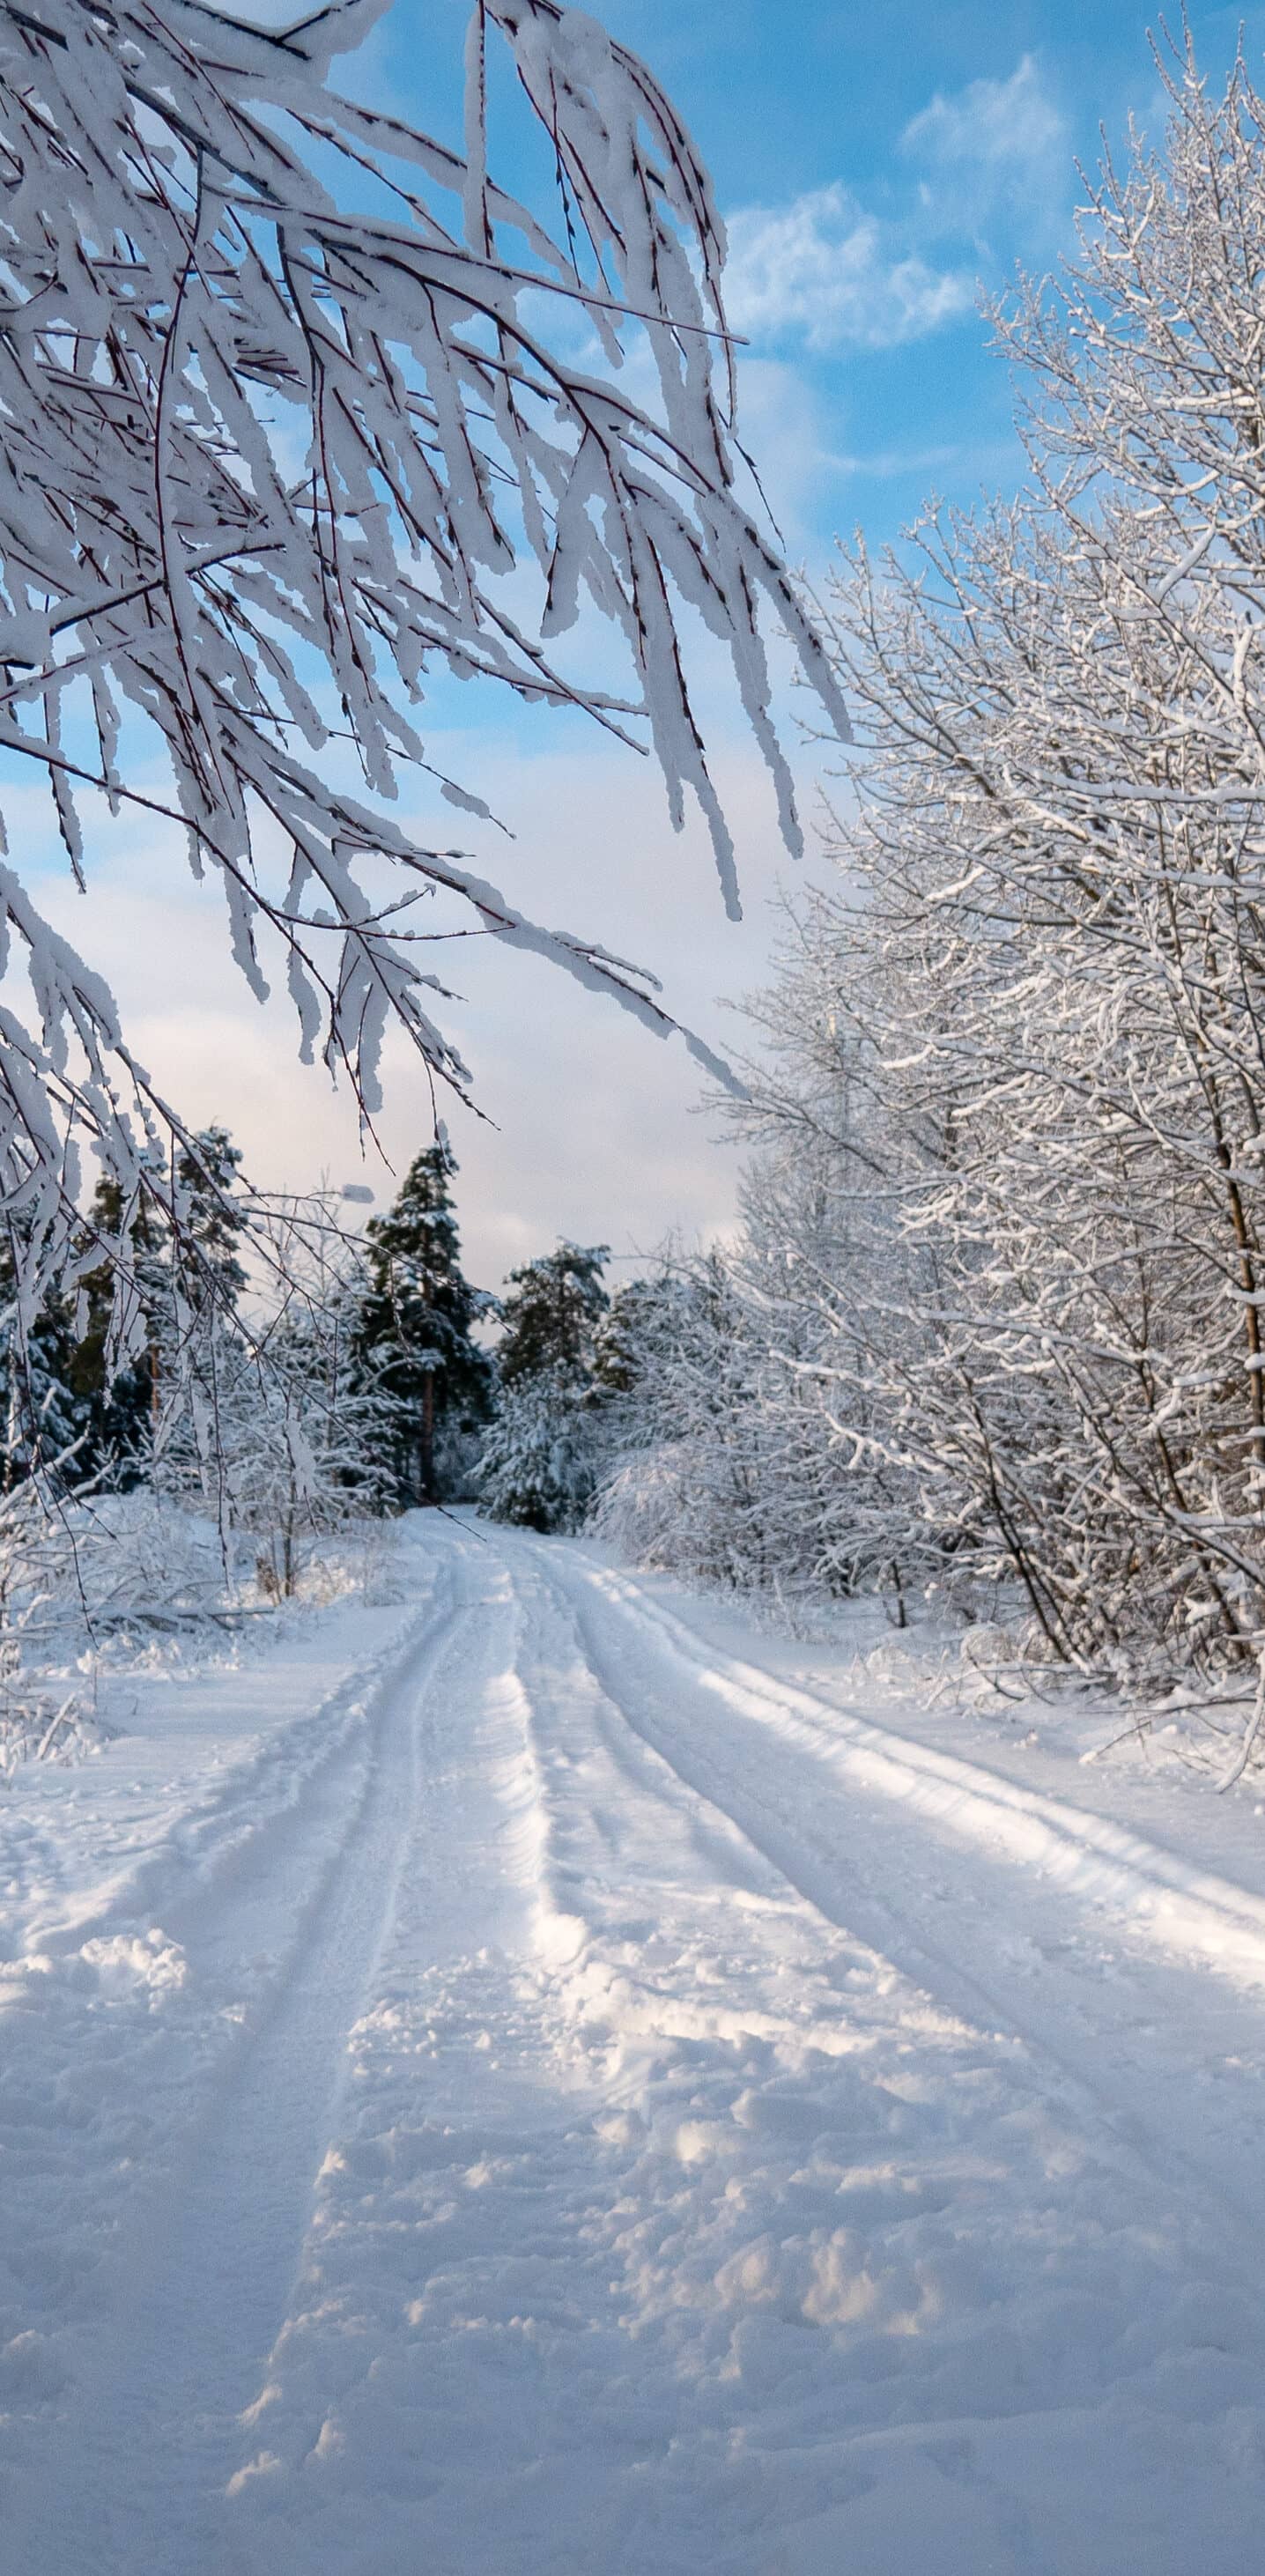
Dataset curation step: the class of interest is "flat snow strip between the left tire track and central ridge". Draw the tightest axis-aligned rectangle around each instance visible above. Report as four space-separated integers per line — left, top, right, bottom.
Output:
222 1536 639 2576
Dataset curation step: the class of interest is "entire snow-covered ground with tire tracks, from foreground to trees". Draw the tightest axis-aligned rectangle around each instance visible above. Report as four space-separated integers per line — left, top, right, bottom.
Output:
0 1514 1265 2576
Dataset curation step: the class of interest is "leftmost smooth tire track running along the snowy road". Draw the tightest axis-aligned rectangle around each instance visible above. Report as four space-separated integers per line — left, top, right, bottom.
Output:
5 1566 482 2576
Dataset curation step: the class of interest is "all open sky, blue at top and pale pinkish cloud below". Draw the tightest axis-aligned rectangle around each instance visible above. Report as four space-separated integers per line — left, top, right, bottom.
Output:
39 0 1265 1285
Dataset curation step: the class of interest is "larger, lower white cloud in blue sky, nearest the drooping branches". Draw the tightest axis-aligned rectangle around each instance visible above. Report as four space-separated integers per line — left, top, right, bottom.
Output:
727 183 974 351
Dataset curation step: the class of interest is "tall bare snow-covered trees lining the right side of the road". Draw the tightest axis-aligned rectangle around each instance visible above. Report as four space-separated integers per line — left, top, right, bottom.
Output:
597 35 1265 1710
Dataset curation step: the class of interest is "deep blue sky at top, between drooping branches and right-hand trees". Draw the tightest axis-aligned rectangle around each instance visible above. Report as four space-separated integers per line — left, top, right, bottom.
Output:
363 0 1265 569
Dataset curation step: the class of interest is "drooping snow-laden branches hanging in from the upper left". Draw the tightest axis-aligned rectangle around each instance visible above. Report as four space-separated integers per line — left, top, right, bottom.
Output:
0 0 838 1308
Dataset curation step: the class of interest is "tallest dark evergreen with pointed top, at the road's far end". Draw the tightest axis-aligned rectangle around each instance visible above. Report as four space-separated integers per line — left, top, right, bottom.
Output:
356 1144 495 1505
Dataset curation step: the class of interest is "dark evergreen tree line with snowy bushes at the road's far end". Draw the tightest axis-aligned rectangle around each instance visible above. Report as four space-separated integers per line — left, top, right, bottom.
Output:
0 1126 649 1597
